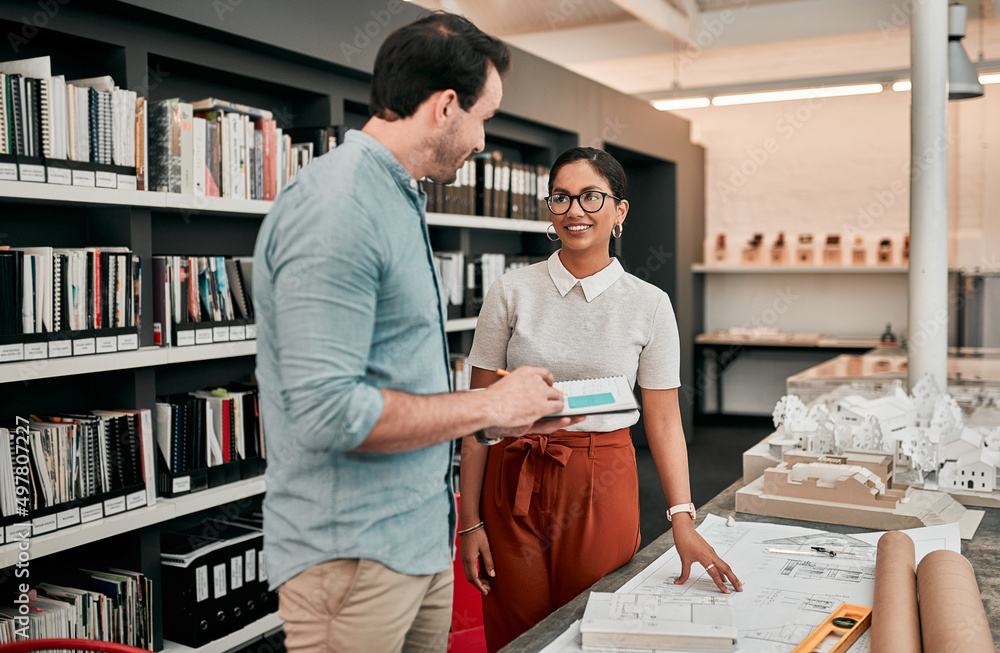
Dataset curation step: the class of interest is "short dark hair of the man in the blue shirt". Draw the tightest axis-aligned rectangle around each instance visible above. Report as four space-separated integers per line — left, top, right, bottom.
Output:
369 12 510 120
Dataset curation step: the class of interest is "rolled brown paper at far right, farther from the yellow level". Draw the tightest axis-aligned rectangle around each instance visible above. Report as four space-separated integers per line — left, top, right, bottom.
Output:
917 551 996 653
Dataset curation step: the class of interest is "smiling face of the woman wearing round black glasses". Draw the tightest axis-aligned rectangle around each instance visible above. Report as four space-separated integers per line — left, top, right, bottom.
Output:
549 161 628 255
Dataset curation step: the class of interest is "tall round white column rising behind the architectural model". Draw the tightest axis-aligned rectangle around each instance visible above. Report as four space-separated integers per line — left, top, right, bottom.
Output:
908 0 948 391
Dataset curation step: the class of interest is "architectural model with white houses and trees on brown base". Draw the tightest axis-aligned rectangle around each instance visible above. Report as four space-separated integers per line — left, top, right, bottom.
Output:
736 377 1000 529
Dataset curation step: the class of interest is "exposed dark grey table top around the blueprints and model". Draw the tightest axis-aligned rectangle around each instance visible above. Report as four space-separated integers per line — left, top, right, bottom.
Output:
501 480 1000 653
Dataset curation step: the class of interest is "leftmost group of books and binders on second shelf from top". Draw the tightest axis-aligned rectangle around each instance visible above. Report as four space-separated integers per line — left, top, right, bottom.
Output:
0 247 142 362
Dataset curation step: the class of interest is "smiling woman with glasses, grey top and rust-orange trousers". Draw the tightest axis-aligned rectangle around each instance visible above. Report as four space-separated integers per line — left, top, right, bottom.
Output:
461 147 742 651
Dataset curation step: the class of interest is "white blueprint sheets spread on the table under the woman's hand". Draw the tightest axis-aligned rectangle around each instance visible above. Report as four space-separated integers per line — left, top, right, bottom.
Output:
543 515 961 653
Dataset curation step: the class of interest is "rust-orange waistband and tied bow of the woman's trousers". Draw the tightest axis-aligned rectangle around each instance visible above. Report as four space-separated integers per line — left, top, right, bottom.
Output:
505 428 632 517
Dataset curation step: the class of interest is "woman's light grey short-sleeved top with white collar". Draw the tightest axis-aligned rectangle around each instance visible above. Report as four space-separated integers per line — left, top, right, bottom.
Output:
469 247 680 431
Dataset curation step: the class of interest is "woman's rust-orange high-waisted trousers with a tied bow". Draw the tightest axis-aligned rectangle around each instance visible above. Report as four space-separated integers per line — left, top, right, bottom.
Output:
479 428 639 653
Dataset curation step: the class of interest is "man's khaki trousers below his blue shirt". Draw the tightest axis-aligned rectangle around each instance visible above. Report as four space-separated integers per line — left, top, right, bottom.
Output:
278 559 454 653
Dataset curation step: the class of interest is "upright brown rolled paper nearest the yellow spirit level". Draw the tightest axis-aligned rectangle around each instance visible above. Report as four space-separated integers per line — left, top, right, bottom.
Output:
871 531 920 653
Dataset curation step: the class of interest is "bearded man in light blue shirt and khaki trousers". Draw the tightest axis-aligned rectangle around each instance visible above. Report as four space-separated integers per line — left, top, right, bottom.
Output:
253 13 578 653
